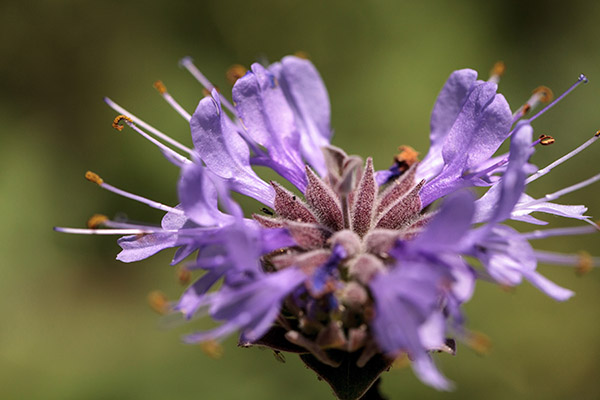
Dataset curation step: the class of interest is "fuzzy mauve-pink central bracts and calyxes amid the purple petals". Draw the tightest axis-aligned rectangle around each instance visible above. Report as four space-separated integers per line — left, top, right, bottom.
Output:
253 148 431 348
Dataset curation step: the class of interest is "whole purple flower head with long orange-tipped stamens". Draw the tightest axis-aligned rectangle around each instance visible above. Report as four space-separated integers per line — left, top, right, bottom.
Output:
56 56 600 399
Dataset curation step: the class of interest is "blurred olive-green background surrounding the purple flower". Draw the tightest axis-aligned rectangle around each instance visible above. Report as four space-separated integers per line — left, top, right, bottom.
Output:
0 0 600 400
